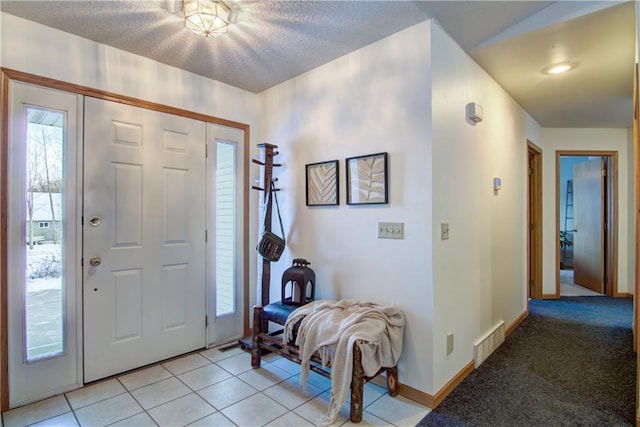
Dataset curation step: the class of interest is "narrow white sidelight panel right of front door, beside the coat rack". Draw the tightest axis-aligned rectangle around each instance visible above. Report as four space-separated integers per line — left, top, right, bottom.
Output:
207 123 246 345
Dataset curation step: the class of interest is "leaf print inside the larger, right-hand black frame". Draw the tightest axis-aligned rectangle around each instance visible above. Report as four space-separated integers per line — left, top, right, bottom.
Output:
351 156 385 203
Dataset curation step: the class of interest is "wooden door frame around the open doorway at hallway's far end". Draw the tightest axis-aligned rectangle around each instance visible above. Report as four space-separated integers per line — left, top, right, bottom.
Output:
555 150 616 298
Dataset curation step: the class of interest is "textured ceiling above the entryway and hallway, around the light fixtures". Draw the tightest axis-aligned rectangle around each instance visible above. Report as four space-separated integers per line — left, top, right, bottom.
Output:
0 0 636 127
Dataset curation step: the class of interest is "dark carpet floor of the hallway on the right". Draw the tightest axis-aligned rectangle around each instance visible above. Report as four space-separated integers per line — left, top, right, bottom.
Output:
418 297 636 427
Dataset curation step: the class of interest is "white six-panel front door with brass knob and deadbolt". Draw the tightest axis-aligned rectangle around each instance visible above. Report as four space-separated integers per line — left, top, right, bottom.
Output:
83 98 206 382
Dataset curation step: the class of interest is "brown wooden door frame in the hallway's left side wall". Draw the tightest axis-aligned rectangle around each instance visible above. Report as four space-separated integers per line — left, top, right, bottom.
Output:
526 140 542 299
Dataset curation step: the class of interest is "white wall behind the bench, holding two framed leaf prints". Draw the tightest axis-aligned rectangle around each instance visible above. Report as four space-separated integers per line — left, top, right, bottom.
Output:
259 22 433 393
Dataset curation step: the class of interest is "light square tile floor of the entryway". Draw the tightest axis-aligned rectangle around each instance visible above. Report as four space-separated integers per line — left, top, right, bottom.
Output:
2 348 429 427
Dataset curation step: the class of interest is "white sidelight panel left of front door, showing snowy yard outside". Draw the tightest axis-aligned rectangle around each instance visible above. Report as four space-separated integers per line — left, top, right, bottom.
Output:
7 81 82 407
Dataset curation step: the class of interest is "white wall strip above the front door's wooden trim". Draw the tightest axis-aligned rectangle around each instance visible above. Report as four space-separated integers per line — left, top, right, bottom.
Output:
1 13 257 124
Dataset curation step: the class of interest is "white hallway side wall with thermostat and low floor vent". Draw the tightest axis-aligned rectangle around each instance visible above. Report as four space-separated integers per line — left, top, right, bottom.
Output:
432 25 539 389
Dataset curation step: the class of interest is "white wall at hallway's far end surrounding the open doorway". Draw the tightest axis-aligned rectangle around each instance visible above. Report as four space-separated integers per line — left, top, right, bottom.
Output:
542 128 634 294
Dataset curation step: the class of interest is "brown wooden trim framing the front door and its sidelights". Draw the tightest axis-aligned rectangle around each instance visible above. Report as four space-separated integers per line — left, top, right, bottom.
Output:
0 67 250 412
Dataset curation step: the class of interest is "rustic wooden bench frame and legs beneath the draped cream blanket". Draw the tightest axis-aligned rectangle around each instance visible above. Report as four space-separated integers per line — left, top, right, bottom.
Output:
251 304 399 423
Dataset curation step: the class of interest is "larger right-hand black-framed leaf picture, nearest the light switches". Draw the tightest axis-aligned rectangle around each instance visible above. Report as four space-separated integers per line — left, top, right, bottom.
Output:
345 152 389 205
